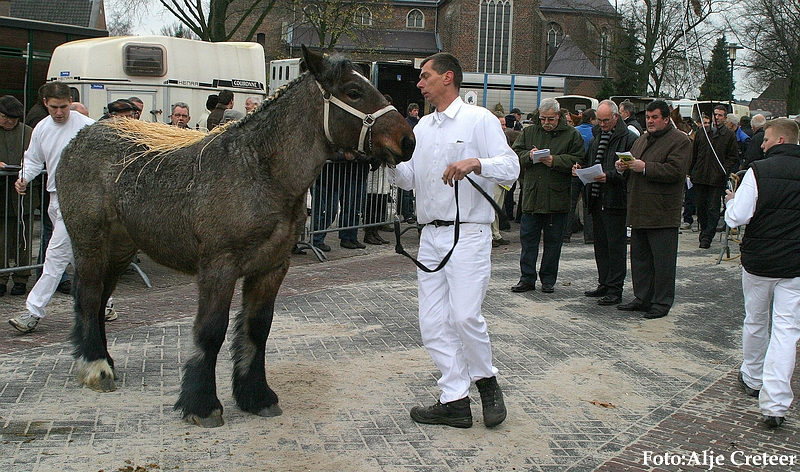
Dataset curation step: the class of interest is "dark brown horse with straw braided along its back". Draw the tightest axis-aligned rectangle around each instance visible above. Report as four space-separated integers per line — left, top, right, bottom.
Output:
56 47 415 427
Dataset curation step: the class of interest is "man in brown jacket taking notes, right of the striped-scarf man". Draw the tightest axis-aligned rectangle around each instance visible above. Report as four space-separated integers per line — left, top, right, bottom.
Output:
616 100 692 319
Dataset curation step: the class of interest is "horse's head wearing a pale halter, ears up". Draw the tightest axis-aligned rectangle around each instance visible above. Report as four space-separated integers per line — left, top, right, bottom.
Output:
303 46 415 166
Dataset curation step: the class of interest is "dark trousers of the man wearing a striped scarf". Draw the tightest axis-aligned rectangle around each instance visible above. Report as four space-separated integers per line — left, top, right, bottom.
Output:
591 202 628 296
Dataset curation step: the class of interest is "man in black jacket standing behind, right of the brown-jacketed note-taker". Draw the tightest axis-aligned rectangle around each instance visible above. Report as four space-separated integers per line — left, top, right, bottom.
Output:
690 105 739 249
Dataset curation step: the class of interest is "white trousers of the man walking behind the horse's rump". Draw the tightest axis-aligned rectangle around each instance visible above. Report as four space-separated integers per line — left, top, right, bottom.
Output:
25 192 72 318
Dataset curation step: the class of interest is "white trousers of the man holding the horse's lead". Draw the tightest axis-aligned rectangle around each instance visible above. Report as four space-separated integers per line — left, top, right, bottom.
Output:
417 223 497 403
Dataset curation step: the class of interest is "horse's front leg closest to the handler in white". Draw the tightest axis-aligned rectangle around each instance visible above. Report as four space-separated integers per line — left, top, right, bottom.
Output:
231 262 289 416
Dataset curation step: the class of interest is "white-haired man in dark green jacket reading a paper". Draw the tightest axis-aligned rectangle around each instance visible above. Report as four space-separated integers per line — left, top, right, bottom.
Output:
511 98 583 293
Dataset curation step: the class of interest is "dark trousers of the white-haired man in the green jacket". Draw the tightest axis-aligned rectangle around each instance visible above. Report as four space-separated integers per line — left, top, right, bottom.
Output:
519 213 567 285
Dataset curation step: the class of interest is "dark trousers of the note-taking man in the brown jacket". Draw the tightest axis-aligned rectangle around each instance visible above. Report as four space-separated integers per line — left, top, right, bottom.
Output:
631 228 678 313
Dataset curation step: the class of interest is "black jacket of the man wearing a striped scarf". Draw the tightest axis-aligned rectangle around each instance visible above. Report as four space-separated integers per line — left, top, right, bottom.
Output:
580 119 638 211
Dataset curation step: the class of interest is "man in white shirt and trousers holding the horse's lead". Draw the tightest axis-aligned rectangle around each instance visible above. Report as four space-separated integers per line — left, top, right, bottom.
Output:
389 53 519 428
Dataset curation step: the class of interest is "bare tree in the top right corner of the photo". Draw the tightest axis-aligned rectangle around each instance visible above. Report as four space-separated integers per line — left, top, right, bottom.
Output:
732 0 800 114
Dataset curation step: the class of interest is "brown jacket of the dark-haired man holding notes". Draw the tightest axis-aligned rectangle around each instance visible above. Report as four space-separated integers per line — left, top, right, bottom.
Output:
625 126 692 229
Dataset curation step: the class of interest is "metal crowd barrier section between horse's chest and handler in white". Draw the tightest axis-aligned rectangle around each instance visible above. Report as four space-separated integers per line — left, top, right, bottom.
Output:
298 160 413 261
